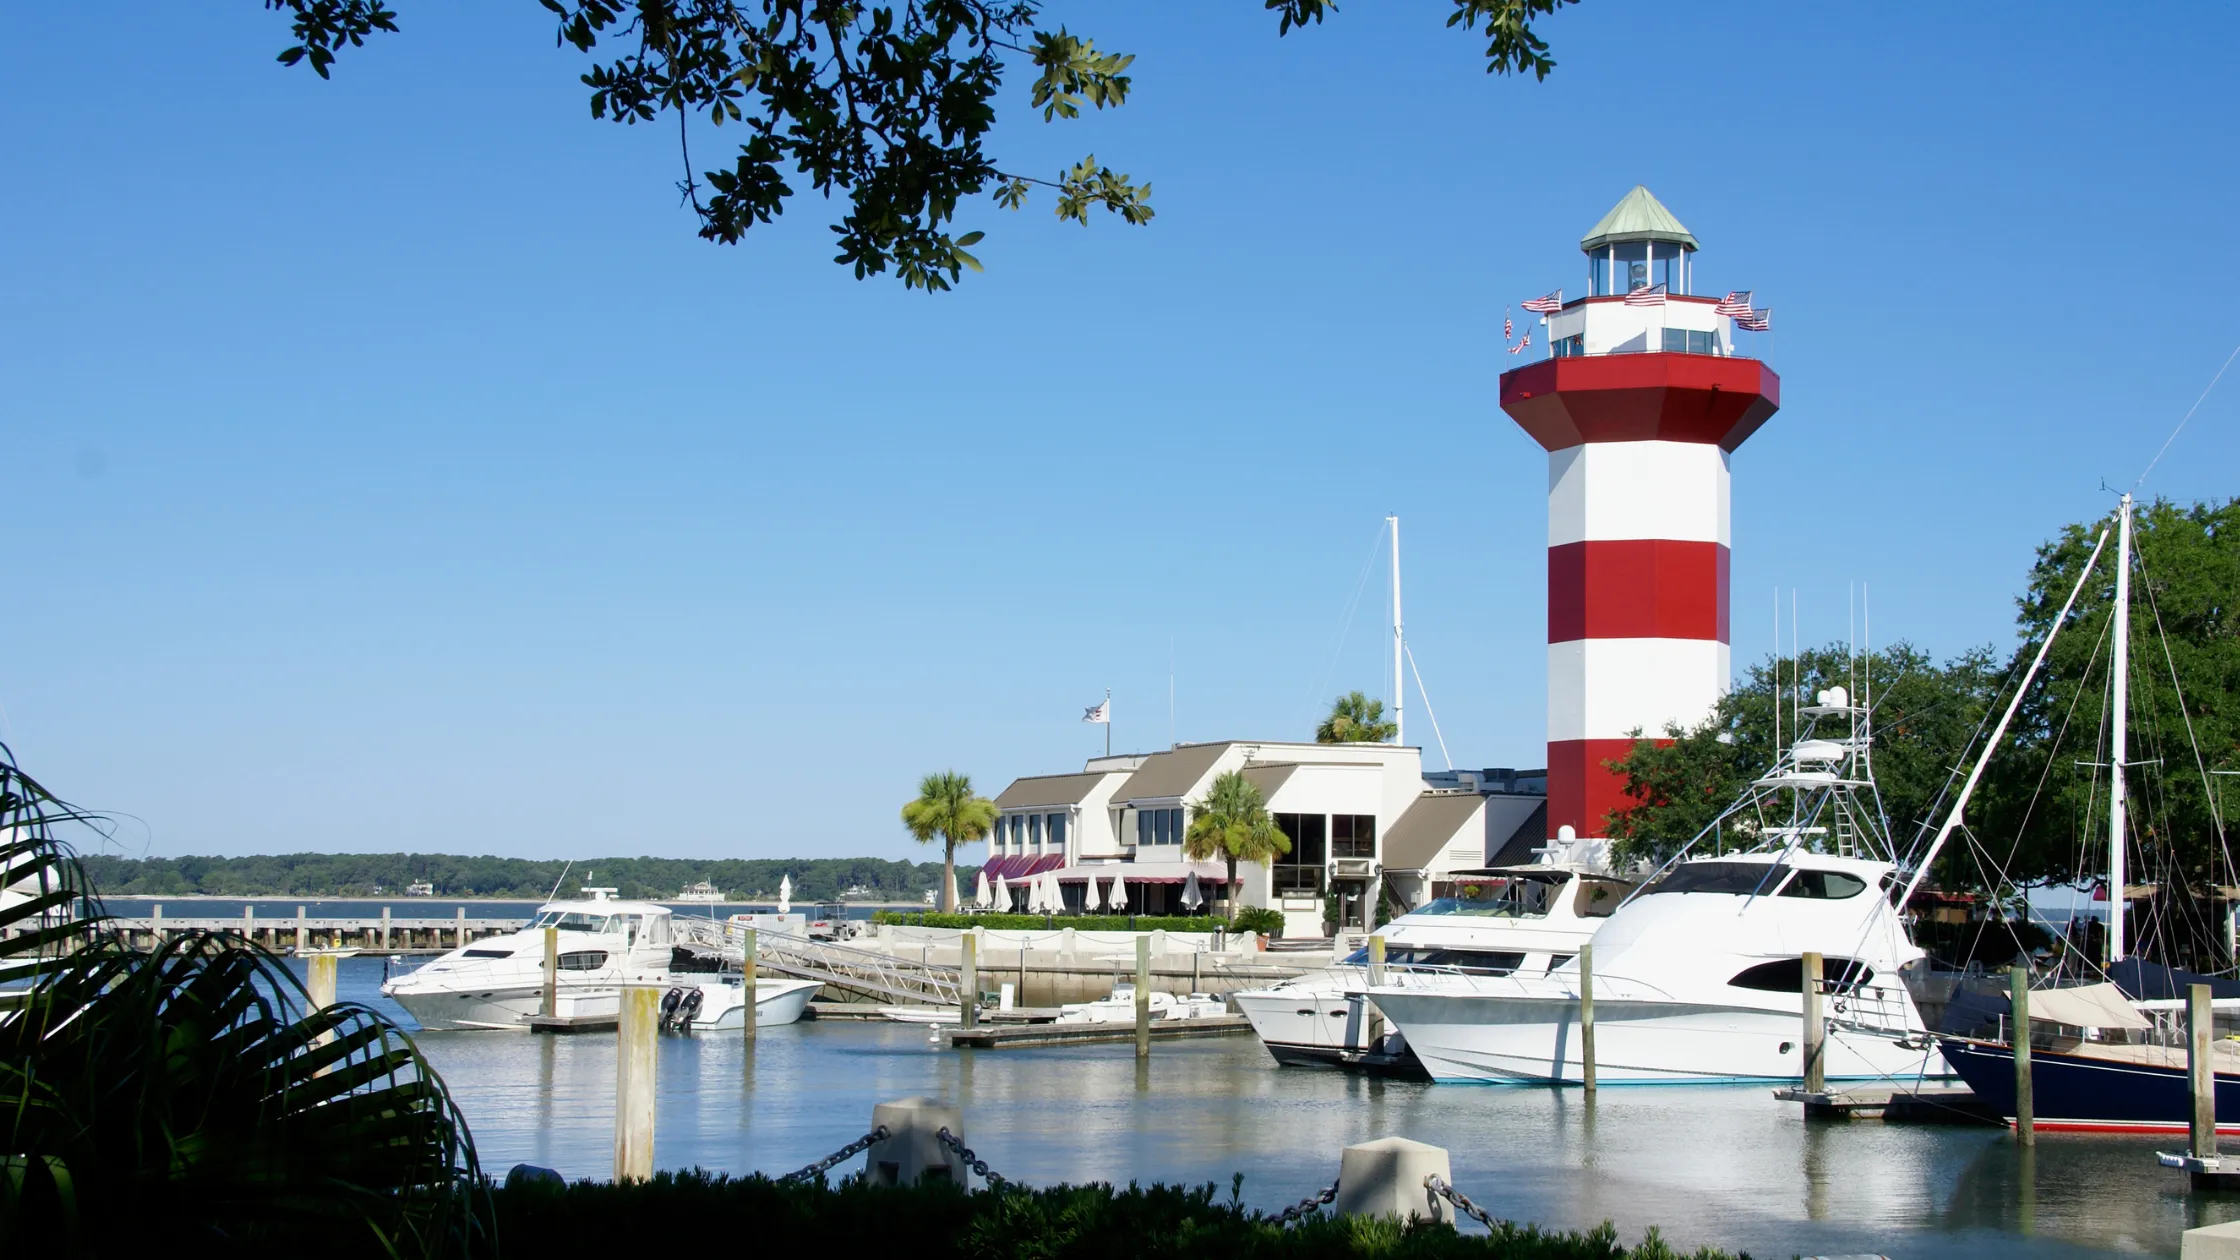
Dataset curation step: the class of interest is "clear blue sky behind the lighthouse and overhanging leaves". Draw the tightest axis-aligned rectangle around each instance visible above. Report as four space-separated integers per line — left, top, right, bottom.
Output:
0 0 2240 856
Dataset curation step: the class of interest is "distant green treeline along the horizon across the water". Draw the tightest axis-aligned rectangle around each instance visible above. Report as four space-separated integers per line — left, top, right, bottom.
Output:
85 854 977 901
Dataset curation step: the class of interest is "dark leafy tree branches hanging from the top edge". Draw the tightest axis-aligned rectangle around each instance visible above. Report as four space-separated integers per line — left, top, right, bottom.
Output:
264 0 1577 291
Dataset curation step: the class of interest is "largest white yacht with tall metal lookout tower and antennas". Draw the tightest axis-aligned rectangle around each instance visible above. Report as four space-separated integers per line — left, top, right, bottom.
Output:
1369 688 1947 1083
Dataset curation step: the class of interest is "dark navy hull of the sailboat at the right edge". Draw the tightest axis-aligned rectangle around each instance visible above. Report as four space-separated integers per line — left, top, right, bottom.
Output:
1940 1038 2240 1132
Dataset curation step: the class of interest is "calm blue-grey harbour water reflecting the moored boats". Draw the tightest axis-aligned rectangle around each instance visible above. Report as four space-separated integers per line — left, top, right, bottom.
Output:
315 957 2240 1260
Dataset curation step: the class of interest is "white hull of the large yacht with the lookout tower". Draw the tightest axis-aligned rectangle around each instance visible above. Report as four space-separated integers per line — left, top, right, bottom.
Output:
1375 991 1947 1085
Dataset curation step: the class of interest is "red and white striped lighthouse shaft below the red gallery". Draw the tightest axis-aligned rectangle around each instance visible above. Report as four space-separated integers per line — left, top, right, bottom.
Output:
1548 442 1732 836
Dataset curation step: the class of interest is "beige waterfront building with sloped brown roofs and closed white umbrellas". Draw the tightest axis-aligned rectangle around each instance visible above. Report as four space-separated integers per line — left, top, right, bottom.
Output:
986 740 1548 937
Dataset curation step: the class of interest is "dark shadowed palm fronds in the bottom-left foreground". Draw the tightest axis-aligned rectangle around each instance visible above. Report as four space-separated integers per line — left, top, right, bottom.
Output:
0 747 491 1256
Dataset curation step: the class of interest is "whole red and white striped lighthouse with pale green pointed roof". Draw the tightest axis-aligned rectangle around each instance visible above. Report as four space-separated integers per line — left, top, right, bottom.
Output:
1501 186 1781 836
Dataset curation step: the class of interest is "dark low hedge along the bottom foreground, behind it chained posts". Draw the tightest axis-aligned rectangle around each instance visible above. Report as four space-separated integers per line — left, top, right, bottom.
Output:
495 1170 1732 1260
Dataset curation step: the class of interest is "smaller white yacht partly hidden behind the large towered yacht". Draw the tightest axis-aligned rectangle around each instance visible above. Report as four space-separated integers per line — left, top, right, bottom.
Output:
1232 861 1633 1067
